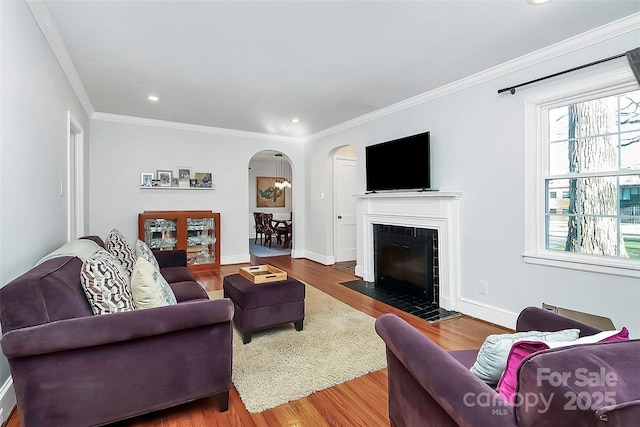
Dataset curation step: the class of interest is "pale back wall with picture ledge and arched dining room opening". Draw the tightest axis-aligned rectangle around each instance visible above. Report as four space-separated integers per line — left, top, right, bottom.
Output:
90 119 304 264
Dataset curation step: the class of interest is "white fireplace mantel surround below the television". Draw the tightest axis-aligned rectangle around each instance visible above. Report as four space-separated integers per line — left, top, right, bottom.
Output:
356 191 462 310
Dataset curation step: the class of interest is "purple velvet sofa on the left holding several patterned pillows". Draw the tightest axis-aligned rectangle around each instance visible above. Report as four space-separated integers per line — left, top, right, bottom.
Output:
0 238 233 427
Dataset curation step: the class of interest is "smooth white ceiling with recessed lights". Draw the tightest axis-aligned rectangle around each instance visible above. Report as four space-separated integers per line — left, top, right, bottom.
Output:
41 0 640 137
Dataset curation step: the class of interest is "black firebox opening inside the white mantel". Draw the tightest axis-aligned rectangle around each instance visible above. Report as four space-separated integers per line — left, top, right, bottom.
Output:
373 224 438 304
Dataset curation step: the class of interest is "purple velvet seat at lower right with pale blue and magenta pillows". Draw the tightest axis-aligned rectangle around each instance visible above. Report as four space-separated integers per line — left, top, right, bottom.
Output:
376 307 640 427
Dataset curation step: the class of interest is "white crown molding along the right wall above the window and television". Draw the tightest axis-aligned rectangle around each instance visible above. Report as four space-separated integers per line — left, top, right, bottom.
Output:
304 13 640 142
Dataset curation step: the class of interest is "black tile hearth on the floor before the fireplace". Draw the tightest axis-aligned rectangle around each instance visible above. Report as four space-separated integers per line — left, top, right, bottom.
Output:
341 280 459 322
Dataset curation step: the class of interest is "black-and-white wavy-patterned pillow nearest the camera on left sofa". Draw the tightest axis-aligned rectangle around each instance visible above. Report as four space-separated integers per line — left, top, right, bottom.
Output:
80 249 135 314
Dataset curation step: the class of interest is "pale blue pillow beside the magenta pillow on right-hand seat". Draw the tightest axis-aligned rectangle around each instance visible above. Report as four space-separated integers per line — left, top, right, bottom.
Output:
471 329 580 385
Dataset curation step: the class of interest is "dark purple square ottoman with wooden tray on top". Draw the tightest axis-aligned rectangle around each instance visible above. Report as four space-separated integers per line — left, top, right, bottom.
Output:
222 274 305 344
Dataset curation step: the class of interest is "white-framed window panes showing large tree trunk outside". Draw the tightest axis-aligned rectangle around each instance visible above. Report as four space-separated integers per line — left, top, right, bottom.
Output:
544 90 640 259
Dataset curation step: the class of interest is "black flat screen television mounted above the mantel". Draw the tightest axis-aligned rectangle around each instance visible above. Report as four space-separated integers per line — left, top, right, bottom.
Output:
365 132 431 192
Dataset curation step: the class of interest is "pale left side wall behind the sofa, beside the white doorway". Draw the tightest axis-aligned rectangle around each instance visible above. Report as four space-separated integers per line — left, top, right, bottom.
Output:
0 1 89 421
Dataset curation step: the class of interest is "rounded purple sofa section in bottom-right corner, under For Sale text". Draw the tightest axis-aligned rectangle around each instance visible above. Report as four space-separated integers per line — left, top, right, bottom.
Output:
515 340 640 427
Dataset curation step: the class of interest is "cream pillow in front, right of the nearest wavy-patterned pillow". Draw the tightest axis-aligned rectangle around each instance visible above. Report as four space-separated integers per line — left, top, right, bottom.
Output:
131 257 177 308
